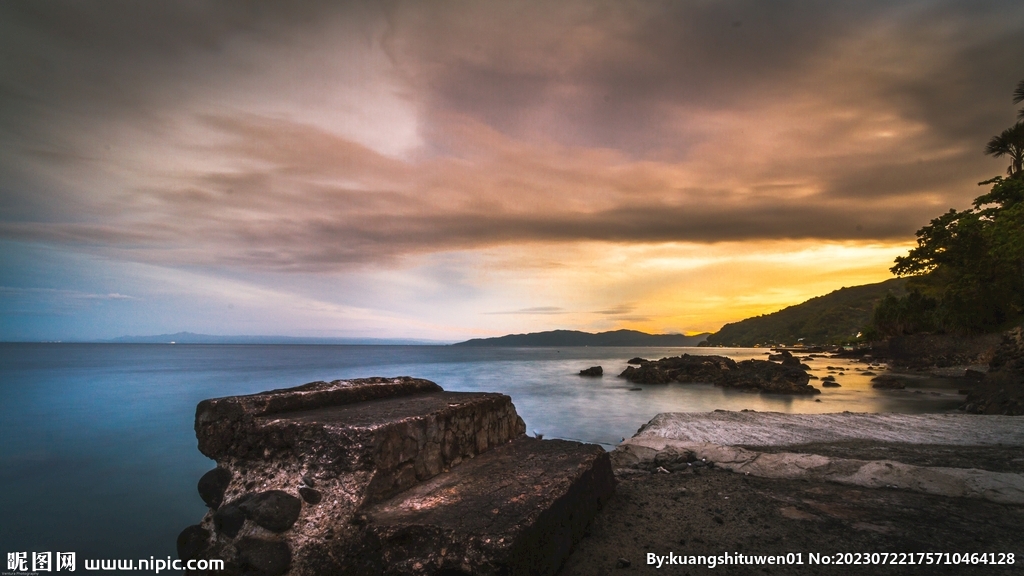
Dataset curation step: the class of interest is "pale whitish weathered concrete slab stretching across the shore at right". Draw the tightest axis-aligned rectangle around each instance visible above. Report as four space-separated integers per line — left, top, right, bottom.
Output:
612 411 1024 504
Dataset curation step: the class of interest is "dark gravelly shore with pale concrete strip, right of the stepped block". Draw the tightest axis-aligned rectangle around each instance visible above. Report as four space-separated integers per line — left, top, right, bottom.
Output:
561 412 1024 576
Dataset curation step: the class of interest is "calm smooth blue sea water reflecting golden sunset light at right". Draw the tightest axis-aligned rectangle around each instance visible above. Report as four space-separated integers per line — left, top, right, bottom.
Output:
0 344 958 559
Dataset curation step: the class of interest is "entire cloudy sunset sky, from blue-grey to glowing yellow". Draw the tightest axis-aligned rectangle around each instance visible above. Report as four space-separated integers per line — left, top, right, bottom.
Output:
0 0 1024 341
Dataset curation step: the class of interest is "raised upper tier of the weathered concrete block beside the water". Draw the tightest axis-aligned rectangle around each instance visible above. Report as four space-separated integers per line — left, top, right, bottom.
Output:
196 378 525 501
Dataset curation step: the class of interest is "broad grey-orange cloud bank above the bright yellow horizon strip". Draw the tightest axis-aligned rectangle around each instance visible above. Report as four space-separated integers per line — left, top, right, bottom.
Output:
0 0 1024 271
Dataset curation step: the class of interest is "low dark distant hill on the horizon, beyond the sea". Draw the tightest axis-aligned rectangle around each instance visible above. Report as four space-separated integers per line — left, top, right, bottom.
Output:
452 330 708 347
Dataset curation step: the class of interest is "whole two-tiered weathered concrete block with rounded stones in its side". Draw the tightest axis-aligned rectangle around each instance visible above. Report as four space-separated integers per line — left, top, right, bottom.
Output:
178 377 613 576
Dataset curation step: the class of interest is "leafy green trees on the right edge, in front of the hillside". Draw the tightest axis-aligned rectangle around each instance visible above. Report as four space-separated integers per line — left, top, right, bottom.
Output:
870 81 1024 337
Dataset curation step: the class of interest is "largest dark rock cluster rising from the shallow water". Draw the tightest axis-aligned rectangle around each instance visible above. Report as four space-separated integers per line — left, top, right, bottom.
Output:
620 354 821 394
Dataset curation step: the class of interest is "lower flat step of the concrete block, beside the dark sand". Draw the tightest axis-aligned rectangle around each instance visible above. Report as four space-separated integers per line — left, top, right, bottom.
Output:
345 437 614 576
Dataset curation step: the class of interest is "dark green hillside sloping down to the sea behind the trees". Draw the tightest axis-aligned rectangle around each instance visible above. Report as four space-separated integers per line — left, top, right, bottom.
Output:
708 278 907 346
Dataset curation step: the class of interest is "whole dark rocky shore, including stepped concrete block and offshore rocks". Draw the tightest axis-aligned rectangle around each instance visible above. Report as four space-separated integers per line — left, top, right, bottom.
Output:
177 329 1024 576
